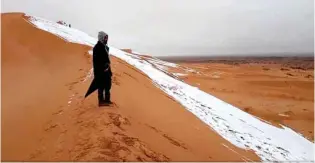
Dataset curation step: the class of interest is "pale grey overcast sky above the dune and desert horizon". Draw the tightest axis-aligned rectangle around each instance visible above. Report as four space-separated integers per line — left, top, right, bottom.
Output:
1 0 314 55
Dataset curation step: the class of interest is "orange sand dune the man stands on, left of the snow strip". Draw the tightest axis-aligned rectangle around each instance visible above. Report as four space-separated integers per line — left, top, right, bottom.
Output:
1 13 262 161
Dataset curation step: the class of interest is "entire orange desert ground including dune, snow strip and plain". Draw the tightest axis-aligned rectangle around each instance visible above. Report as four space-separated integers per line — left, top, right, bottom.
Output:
1 13 314 162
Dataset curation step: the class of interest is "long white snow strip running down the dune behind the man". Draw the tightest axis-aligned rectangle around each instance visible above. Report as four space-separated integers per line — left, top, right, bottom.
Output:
30 14 314 161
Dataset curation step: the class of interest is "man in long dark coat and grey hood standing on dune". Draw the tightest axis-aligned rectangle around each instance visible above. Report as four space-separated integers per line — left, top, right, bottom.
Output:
93 31 112 106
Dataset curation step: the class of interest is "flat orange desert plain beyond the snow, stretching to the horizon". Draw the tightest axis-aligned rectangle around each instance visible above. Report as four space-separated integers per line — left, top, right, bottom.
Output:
165 57 314 142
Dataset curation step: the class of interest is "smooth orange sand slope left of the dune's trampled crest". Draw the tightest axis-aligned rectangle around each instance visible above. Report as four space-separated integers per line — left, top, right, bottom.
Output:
1 14 88 159
